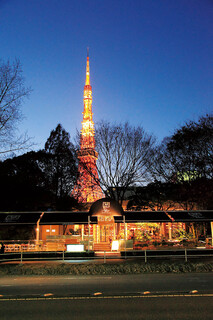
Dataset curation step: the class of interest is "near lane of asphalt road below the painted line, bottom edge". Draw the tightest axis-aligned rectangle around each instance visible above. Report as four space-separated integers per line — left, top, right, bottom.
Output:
0 296 213 320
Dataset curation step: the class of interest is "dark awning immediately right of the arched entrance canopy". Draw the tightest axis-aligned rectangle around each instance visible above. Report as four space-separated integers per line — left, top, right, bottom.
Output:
115 211 172 223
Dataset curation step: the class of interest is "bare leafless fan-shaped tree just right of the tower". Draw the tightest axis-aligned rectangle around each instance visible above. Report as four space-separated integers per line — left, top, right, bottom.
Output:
78 121 155 202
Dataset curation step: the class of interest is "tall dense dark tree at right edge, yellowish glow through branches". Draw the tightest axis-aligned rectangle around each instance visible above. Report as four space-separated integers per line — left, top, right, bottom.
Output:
148 115 213 209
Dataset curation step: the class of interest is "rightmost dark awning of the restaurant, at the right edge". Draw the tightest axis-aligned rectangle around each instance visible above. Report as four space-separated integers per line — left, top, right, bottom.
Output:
167 210 213 222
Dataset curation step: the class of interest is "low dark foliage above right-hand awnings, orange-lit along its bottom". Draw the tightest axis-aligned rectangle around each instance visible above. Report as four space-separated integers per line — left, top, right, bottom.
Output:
128 178 213 210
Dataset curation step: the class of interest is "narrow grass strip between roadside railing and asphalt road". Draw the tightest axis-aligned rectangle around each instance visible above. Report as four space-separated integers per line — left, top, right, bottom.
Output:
0 262 213 277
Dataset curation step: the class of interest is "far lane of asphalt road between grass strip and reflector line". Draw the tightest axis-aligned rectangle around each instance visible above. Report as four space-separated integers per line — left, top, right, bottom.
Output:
0 273 213 297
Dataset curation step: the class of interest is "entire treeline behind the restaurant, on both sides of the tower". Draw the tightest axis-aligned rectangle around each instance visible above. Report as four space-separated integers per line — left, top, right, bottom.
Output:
0 115 213 211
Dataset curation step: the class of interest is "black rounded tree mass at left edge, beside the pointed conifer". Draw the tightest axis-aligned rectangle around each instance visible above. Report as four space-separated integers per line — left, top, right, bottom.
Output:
0 151 54 211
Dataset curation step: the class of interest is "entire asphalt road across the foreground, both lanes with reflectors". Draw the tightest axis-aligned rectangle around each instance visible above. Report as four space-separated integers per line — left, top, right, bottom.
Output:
0 273 213 320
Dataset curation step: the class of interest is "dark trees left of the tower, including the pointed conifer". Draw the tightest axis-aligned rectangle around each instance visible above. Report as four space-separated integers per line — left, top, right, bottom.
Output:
0 124 77 211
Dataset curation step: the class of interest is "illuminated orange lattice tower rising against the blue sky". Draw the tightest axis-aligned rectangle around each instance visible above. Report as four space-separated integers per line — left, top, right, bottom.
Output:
71 52 103 203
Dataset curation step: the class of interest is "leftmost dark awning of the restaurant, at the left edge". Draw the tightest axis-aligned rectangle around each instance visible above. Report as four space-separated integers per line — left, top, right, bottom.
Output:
0 211 42 225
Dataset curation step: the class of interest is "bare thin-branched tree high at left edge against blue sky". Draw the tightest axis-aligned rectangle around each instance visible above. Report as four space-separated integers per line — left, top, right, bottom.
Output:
0 60 31 154
